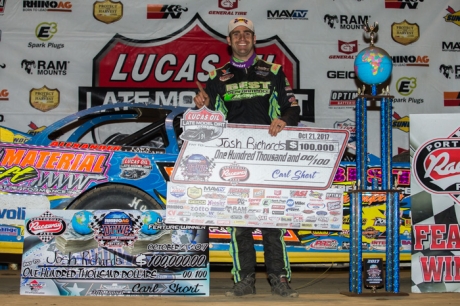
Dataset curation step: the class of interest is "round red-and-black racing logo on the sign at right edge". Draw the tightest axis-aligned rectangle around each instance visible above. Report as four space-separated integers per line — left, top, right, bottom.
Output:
412 128 460 204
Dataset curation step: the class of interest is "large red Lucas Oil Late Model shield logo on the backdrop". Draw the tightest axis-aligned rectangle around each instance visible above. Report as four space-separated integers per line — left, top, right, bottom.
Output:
79 13 300 110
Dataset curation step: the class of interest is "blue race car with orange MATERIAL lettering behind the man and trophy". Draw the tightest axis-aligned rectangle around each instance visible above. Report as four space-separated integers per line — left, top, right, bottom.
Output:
0 103 411 264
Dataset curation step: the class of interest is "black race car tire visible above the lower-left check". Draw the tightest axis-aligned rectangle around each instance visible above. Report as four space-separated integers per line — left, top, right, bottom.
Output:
69 184 163 210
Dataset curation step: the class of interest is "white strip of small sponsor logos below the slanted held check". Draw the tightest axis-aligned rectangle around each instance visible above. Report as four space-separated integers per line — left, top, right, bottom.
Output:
166 182 343 230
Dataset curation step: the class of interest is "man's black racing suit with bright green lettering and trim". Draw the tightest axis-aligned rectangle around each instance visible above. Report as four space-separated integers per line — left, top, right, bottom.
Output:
206 57 300 282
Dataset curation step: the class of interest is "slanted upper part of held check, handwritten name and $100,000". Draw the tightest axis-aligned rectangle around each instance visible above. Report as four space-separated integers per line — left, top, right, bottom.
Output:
171 108 349 190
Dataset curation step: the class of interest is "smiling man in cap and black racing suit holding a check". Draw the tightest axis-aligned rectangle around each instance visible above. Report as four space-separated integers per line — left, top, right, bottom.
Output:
194 17 300 297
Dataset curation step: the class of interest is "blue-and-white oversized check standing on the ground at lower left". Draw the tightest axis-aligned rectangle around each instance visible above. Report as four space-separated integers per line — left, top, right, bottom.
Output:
20 209 209 296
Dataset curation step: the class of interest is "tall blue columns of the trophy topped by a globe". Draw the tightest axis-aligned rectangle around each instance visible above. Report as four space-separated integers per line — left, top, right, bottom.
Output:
349 89 400 294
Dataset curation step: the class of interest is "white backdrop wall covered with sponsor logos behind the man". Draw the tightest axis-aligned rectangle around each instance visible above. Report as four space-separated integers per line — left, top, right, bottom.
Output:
0 0 460 160
